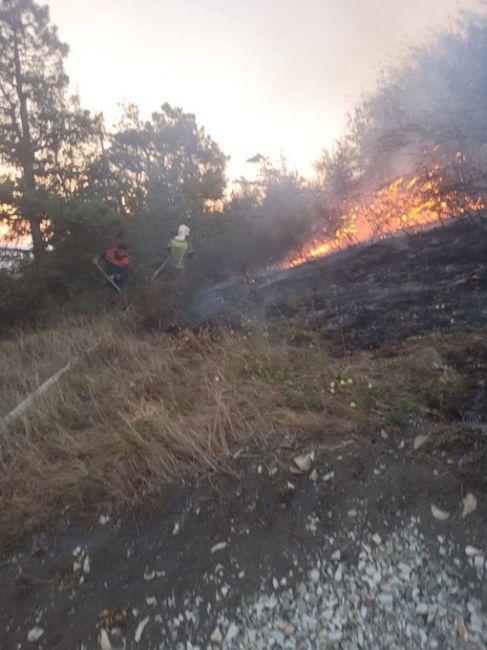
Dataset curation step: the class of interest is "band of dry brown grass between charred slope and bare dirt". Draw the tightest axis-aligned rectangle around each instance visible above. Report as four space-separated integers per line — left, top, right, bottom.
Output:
0 319 482 537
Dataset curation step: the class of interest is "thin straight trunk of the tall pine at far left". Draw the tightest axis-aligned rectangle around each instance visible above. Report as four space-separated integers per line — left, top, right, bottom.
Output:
14 27 45 259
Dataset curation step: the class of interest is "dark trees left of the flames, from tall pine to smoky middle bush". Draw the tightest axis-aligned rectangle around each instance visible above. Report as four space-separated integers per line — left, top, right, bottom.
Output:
0 0 314 322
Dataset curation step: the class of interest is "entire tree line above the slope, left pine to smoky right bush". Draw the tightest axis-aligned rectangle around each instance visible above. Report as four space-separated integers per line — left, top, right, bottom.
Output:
16 0 487 322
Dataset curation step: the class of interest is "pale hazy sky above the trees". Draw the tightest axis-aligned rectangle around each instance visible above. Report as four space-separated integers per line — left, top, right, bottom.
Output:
48 0 480 177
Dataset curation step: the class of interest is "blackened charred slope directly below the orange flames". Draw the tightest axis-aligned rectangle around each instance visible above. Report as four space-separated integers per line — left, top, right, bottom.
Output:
187 219 487 352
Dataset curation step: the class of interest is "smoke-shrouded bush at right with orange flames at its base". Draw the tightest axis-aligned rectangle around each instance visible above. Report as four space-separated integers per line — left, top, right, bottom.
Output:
300 9 487 265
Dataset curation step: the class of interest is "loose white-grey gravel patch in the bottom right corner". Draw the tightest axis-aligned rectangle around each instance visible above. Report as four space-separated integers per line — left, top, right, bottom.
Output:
149 521 487 650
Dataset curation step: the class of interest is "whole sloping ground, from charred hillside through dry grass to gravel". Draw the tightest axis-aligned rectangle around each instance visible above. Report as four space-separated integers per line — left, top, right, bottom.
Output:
0 221 487 650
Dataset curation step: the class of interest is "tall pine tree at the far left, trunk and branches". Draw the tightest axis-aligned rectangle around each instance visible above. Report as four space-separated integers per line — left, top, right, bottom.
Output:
0 0 101 257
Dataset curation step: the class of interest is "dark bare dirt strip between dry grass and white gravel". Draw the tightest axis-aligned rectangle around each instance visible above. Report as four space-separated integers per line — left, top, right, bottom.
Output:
0 431 487 650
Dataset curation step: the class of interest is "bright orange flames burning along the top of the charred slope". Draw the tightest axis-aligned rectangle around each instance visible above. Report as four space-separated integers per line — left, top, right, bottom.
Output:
284 165 485 268
